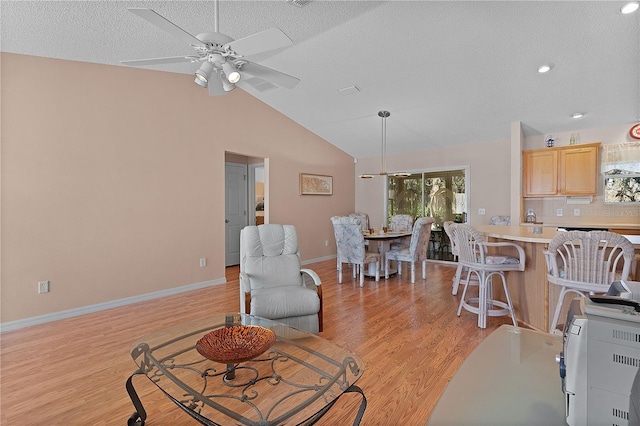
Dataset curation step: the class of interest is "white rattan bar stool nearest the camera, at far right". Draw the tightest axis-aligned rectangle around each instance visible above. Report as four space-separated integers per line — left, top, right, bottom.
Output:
544 231 635 333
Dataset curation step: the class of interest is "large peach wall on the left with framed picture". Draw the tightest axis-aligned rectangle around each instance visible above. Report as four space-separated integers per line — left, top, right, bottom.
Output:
0 53 354 323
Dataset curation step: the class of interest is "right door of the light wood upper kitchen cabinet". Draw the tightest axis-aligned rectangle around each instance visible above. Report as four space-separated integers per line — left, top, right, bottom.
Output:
559 146 598 195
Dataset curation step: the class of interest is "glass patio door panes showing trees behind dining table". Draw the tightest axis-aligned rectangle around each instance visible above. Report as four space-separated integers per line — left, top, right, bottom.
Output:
387 169 467 227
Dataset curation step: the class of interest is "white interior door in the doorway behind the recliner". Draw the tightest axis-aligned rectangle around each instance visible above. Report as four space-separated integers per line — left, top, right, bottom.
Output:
224 163 247 266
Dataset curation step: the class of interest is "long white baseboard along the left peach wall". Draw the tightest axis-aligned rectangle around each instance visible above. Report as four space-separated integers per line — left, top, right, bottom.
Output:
0 278 227 333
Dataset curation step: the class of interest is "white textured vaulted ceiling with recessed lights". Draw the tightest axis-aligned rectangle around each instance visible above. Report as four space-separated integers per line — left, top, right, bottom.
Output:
0 0 640 157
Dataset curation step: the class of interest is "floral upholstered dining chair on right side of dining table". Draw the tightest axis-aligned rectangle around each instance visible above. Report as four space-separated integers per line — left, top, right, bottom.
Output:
384 217 435 284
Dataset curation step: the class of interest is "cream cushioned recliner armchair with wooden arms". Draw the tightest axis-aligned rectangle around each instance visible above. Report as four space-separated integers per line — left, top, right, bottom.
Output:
240 224 322 333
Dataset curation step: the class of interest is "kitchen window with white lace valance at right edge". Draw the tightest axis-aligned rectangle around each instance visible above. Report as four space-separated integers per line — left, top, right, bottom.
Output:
602 142 640 204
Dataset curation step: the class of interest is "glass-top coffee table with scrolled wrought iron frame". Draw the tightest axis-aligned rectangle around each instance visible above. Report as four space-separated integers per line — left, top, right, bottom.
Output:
126 314 366 426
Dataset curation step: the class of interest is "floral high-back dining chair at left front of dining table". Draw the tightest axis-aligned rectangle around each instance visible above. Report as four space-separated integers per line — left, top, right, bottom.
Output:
331 216 381 287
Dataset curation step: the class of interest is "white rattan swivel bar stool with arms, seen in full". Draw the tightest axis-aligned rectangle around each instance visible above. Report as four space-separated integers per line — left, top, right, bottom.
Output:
453 223 525 328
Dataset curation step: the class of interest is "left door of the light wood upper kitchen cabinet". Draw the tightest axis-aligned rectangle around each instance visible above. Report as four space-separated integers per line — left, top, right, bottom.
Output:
522 149 558 197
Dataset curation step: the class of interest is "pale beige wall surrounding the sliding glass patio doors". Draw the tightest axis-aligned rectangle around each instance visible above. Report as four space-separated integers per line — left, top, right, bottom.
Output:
356 140 510 227
